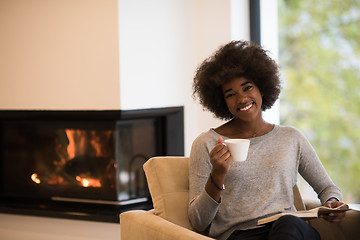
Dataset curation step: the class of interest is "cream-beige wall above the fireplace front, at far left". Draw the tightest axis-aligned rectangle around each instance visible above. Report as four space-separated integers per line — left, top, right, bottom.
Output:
0 0 120 110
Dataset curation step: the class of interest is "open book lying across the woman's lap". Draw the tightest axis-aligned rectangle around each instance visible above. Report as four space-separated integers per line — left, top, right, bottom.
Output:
257 205 350 225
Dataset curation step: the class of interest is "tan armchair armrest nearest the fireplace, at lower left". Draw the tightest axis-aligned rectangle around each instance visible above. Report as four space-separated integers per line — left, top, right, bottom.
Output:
120 210 212 240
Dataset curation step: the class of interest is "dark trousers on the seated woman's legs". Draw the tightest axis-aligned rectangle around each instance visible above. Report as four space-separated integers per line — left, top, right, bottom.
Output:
228 215 320 240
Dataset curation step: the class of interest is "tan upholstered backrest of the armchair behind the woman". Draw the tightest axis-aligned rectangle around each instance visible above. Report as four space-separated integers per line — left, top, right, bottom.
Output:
143 157 305 230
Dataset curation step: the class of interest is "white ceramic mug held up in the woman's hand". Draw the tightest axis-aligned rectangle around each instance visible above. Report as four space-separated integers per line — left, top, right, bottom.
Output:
224 139 250 162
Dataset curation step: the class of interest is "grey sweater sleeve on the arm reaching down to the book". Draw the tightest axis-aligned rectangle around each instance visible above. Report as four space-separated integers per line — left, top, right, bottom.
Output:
299 128 342 204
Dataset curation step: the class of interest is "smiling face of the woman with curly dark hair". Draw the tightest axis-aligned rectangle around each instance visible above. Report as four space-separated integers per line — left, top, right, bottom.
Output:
222 77 262 122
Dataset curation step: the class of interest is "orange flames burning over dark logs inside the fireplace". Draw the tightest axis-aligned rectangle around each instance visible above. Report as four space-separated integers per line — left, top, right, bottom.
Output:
51 128 114 188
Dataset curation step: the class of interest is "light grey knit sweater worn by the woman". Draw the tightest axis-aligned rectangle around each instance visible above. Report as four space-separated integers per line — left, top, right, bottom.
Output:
188 125 342 239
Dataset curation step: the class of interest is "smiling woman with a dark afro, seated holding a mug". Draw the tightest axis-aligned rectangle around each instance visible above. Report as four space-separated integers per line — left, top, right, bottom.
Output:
189 41 348 239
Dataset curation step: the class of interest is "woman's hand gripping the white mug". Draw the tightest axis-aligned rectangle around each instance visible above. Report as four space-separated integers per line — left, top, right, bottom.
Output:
210 137 233 177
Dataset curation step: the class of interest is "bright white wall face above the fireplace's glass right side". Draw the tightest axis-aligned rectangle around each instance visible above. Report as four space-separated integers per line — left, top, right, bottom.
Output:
118 0 188 110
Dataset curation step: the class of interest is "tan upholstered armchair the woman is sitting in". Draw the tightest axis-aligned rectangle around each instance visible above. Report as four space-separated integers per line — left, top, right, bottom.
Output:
120 157 360 240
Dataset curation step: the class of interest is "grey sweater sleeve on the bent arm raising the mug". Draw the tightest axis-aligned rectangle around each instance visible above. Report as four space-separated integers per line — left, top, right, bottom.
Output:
188 135 220 232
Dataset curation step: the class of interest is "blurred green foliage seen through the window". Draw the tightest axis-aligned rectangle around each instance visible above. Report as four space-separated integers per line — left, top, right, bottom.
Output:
279 0 360 203
